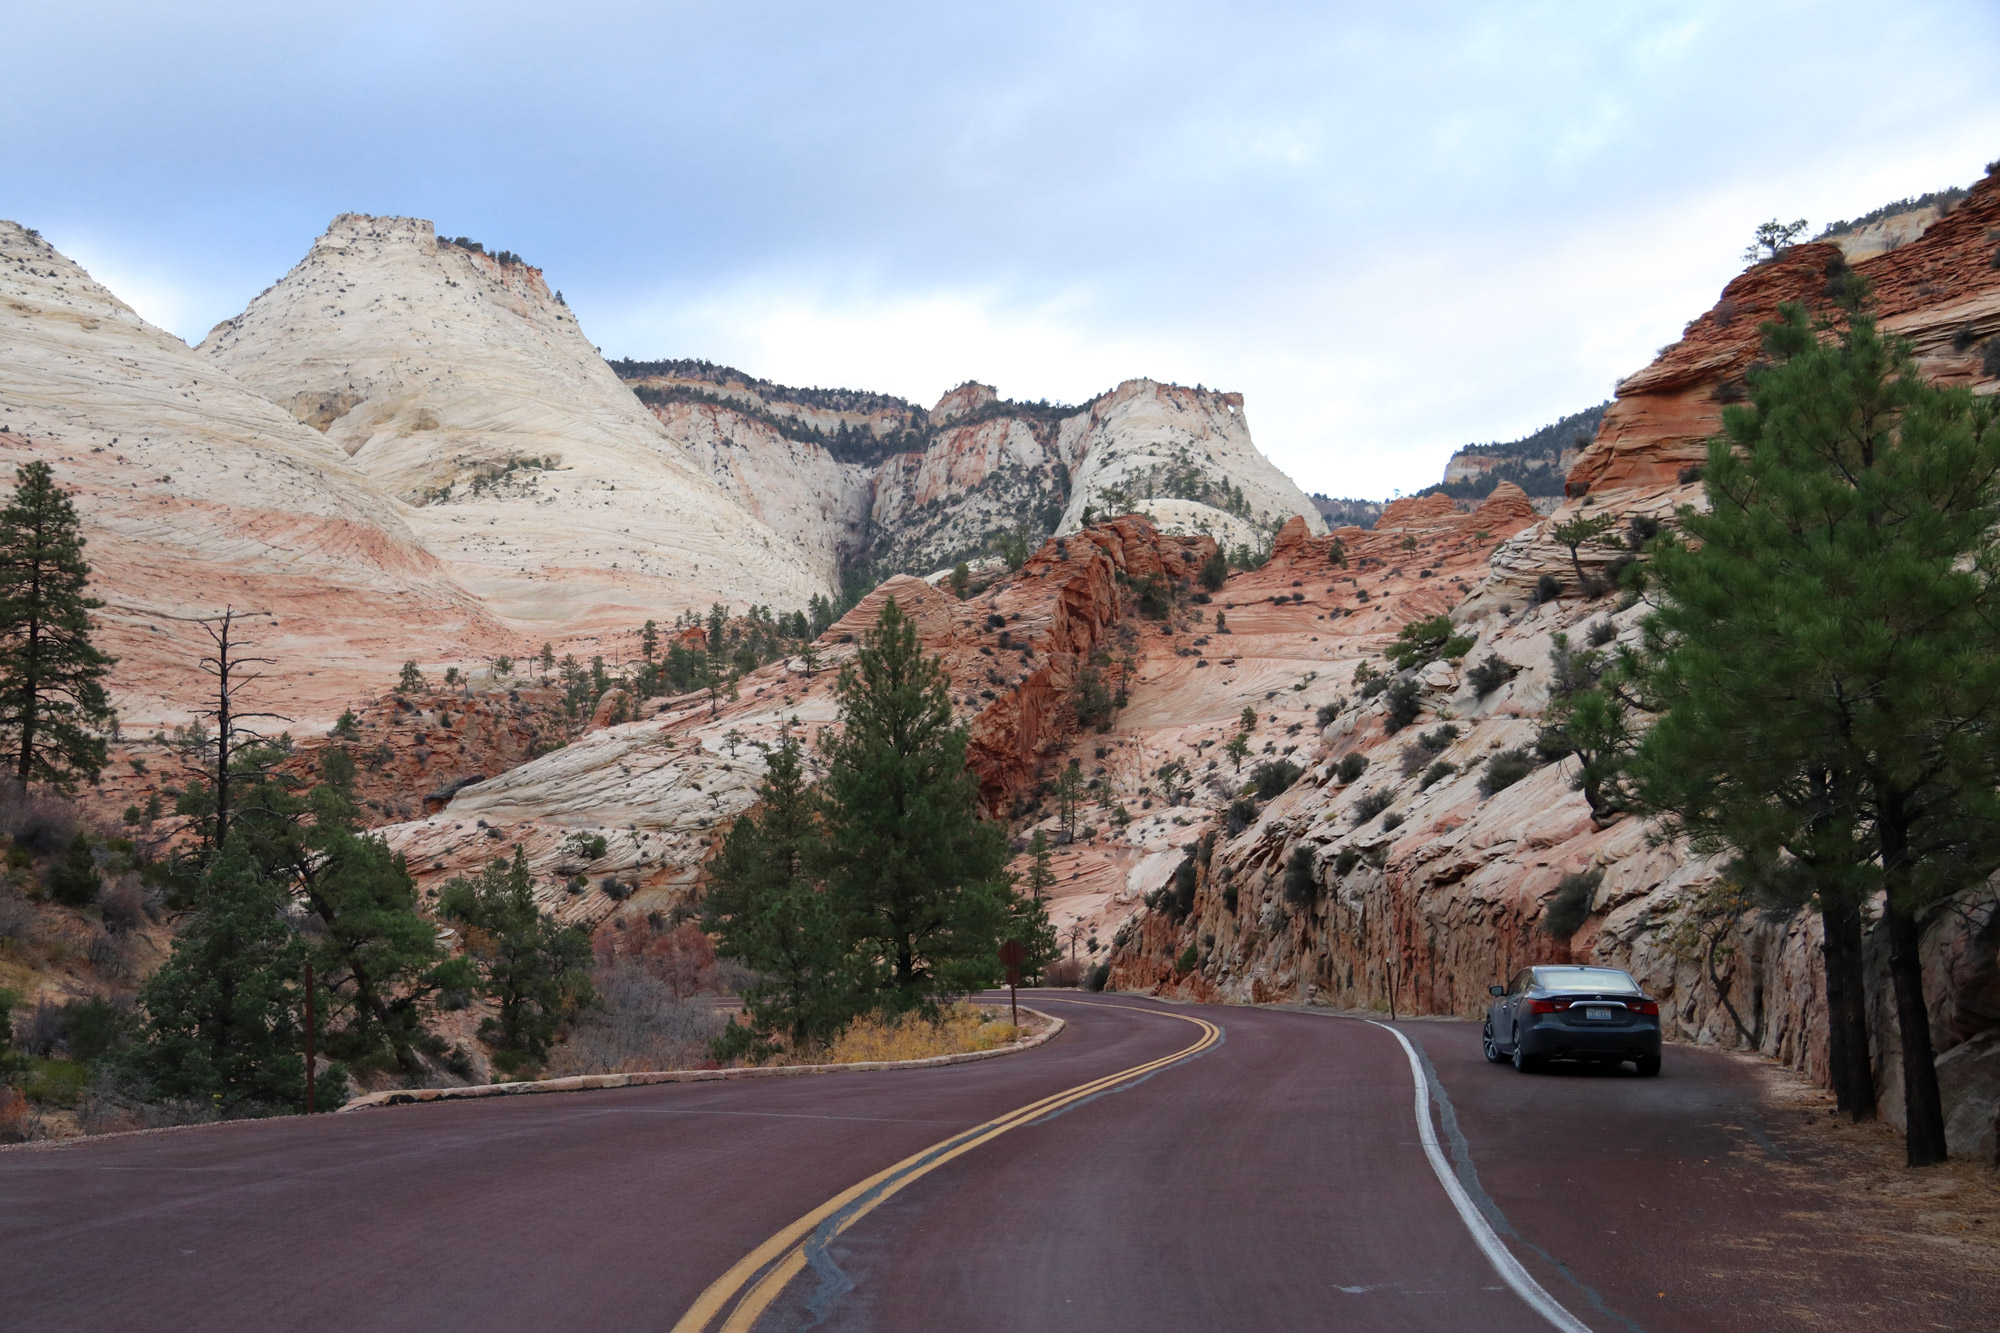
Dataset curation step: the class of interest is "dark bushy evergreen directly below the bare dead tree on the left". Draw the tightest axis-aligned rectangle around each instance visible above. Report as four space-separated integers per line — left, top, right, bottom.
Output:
132 839 306 1115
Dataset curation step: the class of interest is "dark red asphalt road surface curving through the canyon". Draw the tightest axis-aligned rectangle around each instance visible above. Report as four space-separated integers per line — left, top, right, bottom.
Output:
0 993 1980 1333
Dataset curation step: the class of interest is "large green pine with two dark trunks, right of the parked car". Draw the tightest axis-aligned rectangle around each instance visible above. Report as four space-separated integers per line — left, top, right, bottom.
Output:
1632 306 2000 1165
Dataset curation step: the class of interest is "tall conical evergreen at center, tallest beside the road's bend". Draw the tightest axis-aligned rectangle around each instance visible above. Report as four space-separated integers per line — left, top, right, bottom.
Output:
822 598 1012 1009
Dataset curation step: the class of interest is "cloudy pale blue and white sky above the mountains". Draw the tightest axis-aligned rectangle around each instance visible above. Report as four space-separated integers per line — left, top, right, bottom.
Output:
0 0 2000 496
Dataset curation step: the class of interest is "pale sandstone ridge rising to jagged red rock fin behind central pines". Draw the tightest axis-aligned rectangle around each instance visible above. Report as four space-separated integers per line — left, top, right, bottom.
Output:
384 518 1214 923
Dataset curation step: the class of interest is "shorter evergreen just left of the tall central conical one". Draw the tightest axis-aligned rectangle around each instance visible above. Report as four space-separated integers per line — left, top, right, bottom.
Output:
702 735 866 1059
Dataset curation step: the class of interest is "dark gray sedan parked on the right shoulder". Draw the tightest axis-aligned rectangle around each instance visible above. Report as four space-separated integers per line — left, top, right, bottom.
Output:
1482 965 1660 1077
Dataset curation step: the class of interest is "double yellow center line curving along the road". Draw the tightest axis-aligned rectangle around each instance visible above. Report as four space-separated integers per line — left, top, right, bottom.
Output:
674 1001 1222 1333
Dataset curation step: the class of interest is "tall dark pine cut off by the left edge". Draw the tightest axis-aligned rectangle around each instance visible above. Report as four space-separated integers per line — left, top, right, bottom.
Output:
0 460 116 791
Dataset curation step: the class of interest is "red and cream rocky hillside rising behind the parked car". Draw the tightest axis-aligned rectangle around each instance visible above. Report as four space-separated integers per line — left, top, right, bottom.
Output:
1112 166 2000 1159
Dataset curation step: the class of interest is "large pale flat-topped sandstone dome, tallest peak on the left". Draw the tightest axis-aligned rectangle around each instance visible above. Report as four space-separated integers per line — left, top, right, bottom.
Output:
198 214 834 632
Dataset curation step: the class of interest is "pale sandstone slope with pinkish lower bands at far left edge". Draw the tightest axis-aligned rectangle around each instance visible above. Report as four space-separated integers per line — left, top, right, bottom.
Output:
0 222 504 727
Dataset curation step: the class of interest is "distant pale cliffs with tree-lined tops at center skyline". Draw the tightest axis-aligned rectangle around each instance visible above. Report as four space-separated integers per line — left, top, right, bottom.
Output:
614 360 1322 578
